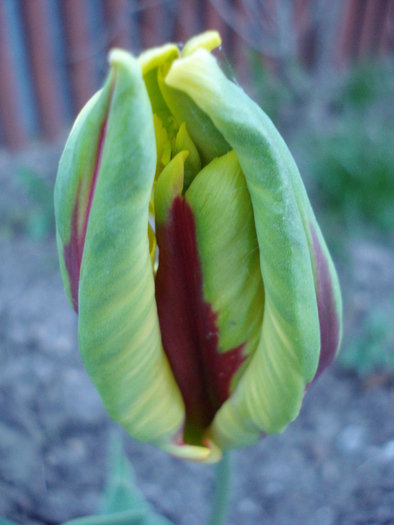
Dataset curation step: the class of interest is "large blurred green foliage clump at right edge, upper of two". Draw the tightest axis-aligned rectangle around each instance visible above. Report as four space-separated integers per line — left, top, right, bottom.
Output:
310 63 394 231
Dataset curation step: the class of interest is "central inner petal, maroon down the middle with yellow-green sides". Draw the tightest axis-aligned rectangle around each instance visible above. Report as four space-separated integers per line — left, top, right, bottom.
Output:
155 152 248 444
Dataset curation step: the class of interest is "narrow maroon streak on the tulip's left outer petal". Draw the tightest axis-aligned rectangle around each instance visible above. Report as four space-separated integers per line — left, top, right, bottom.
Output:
63 119 107 313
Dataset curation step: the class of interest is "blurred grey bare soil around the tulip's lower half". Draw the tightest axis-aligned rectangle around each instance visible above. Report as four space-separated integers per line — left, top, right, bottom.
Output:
0 147 394 525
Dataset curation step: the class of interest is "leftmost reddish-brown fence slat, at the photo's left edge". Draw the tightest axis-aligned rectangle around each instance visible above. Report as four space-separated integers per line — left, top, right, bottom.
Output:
0 2 26 149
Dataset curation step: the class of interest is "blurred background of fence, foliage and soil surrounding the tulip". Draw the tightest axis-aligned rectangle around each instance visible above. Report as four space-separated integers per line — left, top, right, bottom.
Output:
0 0 394 525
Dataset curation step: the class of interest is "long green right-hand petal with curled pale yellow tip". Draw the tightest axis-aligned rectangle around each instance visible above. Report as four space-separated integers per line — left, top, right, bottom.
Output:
166 49 335 448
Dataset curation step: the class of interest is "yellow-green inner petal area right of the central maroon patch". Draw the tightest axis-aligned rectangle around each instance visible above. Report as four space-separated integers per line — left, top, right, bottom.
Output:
186 151 264 370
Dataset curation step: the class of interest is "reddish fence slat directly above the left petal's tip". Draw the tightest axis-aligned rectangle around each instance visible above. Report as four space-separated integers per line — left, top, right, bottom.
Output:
104 0 131 50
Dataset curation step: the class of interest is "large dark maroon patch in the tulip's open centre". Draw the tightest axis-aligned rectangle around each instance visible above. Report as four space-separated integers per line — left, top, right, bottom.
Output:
156 197 245 430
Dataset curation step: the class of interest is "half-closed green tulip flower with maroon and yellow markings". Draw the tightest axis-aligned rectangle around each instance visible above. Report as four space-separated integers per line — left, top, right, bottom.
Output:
55 32 342 462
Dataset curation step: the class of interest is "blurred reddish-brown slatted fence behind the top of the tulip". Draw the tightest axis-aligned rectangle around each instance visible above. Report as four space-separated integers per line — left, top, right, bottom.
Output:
0 0 394 149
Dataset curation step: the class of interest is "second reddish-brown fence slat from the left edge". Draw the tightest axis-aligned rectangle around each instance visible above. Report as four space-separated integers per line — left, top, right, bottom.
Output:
21 0 62 138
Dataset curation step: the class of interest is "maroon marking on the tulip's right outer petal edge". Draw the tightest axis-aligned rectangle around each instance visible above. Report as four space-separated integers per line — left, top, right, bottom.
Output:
311 225 339 381
